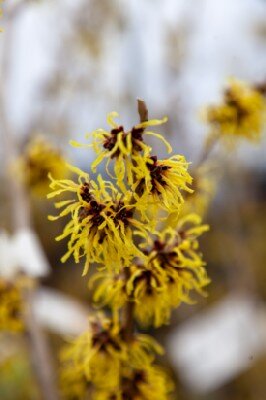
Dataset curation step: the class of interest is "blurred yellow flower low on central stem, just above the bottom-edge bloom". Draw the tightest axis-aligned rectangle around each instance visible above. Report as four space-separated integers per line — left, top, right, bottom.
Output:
61 314 162 399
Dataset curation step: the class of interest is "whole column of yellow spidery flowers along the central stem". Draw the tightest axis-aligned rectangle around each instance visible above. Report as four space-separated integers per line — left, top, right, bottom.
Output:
48 108 209 399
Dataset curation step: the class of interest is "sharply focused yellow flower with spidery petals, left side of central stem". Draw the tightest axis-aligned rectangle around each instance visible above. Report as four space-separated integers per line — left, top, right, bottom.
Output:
48 166 150 274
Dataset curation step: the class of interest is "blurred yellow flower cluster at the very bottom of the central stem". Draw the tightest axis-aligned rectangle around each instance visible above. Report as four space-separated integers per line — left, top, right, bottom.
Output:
62 315 172 400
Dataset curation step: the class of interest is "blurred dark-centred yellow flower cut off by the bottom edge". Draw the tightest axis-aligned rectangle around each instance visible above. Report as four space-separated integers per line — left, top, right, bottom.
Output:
93 366 173 400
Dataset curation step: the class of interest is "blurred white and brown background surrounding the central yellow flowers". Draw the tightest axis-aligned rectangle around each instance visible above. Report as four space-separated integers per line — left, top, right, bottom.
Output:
0 0 266 400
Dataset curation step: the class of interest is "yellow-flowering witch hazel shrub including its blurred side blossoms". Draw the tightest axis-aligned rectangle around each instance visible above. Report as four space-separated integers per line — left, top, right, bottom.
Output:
0 76 266 400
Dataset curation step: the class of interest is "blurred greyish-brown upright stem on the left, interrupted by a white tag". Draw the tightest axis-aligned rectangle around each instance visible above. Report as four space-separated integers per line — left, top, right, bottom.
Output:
0 9 58 400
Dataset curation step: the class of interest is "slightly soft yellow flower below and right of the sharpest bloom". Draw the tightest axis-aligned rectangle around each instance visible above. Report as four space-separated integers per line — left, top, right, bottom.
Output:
90 214 209 327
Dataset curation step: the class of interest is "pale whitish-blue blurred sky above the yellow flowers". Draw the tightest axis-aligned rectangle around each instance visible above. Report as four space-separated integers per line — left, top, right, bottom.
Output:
0 0 266 163
